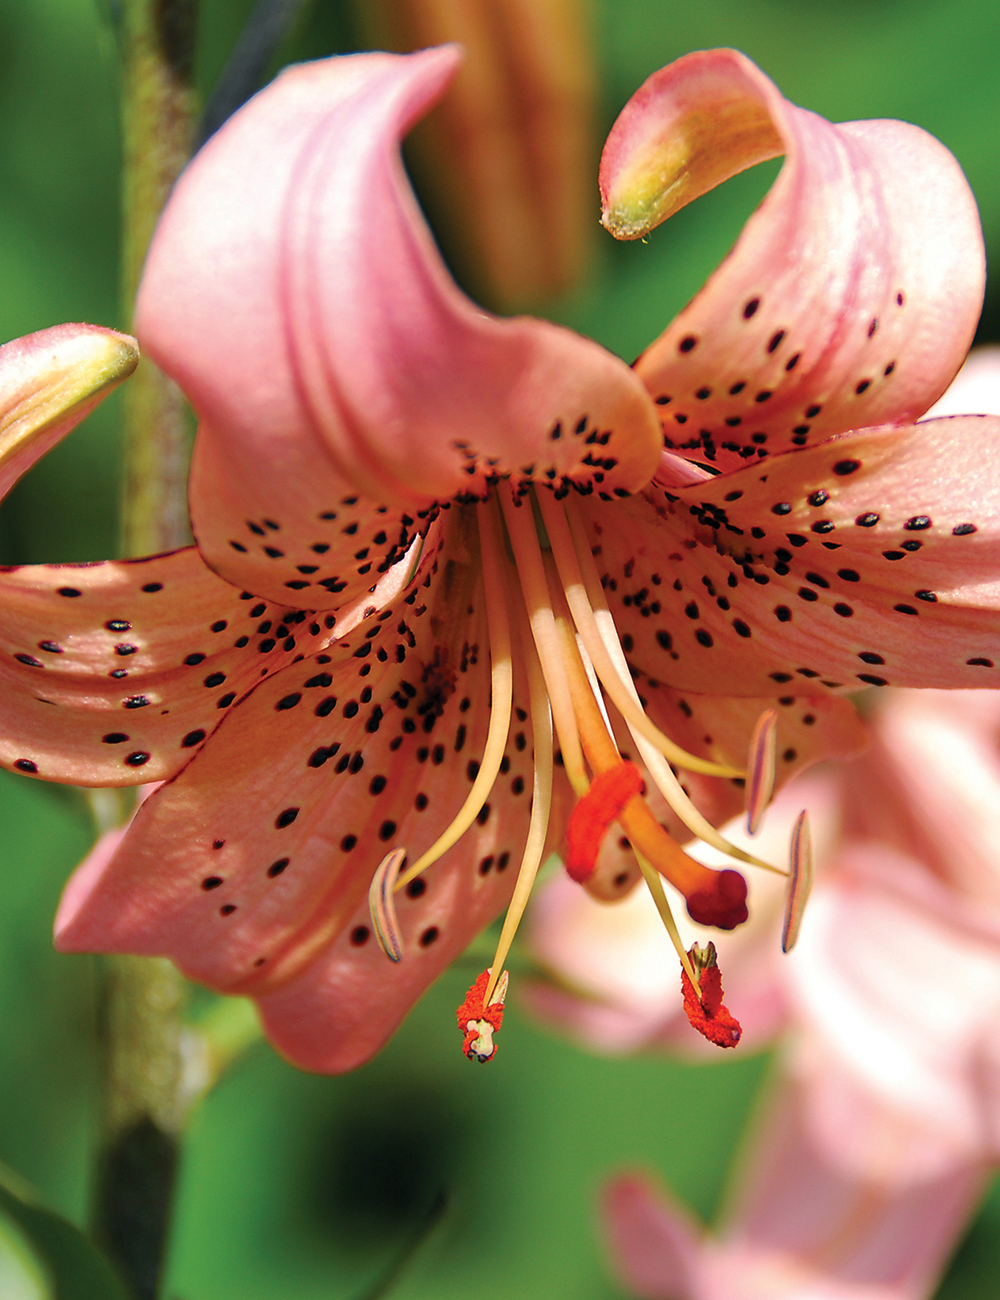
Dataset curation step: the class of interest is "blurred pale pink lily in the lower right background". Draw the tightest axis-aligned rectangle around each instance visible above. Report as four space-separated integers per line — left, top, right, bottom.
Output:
534 686 1000 1300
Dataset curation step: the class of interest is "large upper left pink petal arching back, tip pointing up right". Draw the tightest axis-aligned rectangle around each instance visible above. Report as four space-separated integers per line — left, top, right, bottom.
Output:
137 48 661 605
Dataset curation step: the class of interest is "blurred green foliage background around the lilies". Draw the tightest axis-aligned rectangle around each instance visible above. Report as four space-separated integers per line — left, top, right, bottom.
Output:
0 0 1000 1300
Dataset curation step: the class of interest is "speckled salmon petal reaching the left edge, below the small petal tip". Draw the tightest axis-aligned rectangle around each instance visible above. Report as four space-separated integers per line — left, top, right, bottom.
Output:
0 547 331 785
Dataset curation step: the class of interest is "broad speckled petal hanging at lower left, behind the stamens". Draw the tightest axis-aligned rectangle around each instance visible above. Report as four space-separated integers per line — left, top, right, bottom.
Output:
57 521 561 1070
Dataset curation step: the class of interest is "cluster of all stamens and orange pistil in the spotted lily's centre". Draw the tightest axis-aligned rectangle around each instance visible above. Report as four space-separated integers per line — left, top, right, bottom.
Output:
369 482 795 1060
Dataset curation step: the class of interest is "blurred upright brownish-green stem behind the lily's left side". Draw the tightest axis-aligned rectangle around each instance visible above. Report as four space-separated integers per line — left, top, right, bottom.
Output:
94 0 195 1300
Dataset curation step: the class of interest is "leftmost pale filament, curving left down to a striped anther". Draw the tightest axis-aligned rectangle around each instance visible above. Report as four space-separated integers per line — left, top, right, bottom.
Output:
395 503 514 889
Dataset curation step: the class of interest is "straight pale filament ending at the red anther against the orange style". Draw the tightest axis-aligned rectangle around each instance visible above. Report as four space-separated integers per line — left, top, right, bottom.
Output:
501 493 589 798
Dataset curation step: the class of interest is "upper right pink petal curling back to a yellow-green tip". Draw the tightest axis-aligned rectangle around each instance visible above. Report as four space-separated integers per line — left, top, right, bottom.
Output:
601 49 984 468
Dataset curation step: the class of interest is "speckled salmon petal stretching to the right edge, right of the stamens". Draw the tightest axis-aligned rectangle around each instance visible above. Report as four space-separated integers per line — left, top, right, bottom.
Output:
585 416 1000 696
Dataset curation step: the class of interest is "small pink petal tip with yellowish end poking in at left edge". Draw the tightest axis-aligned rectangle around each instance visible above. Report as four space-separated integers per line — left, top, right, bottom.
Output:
0 325 139 497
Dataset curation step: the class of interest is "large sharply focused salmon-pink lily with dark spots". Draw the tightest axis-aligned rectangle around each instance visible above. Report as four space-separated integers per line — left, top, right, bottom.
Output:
50 47 1000 1071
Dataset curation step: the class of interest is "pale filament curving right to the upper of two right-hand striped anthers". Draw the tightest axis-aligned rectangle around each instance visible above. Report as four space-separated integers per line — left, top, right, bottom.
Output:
538 491 745 777
